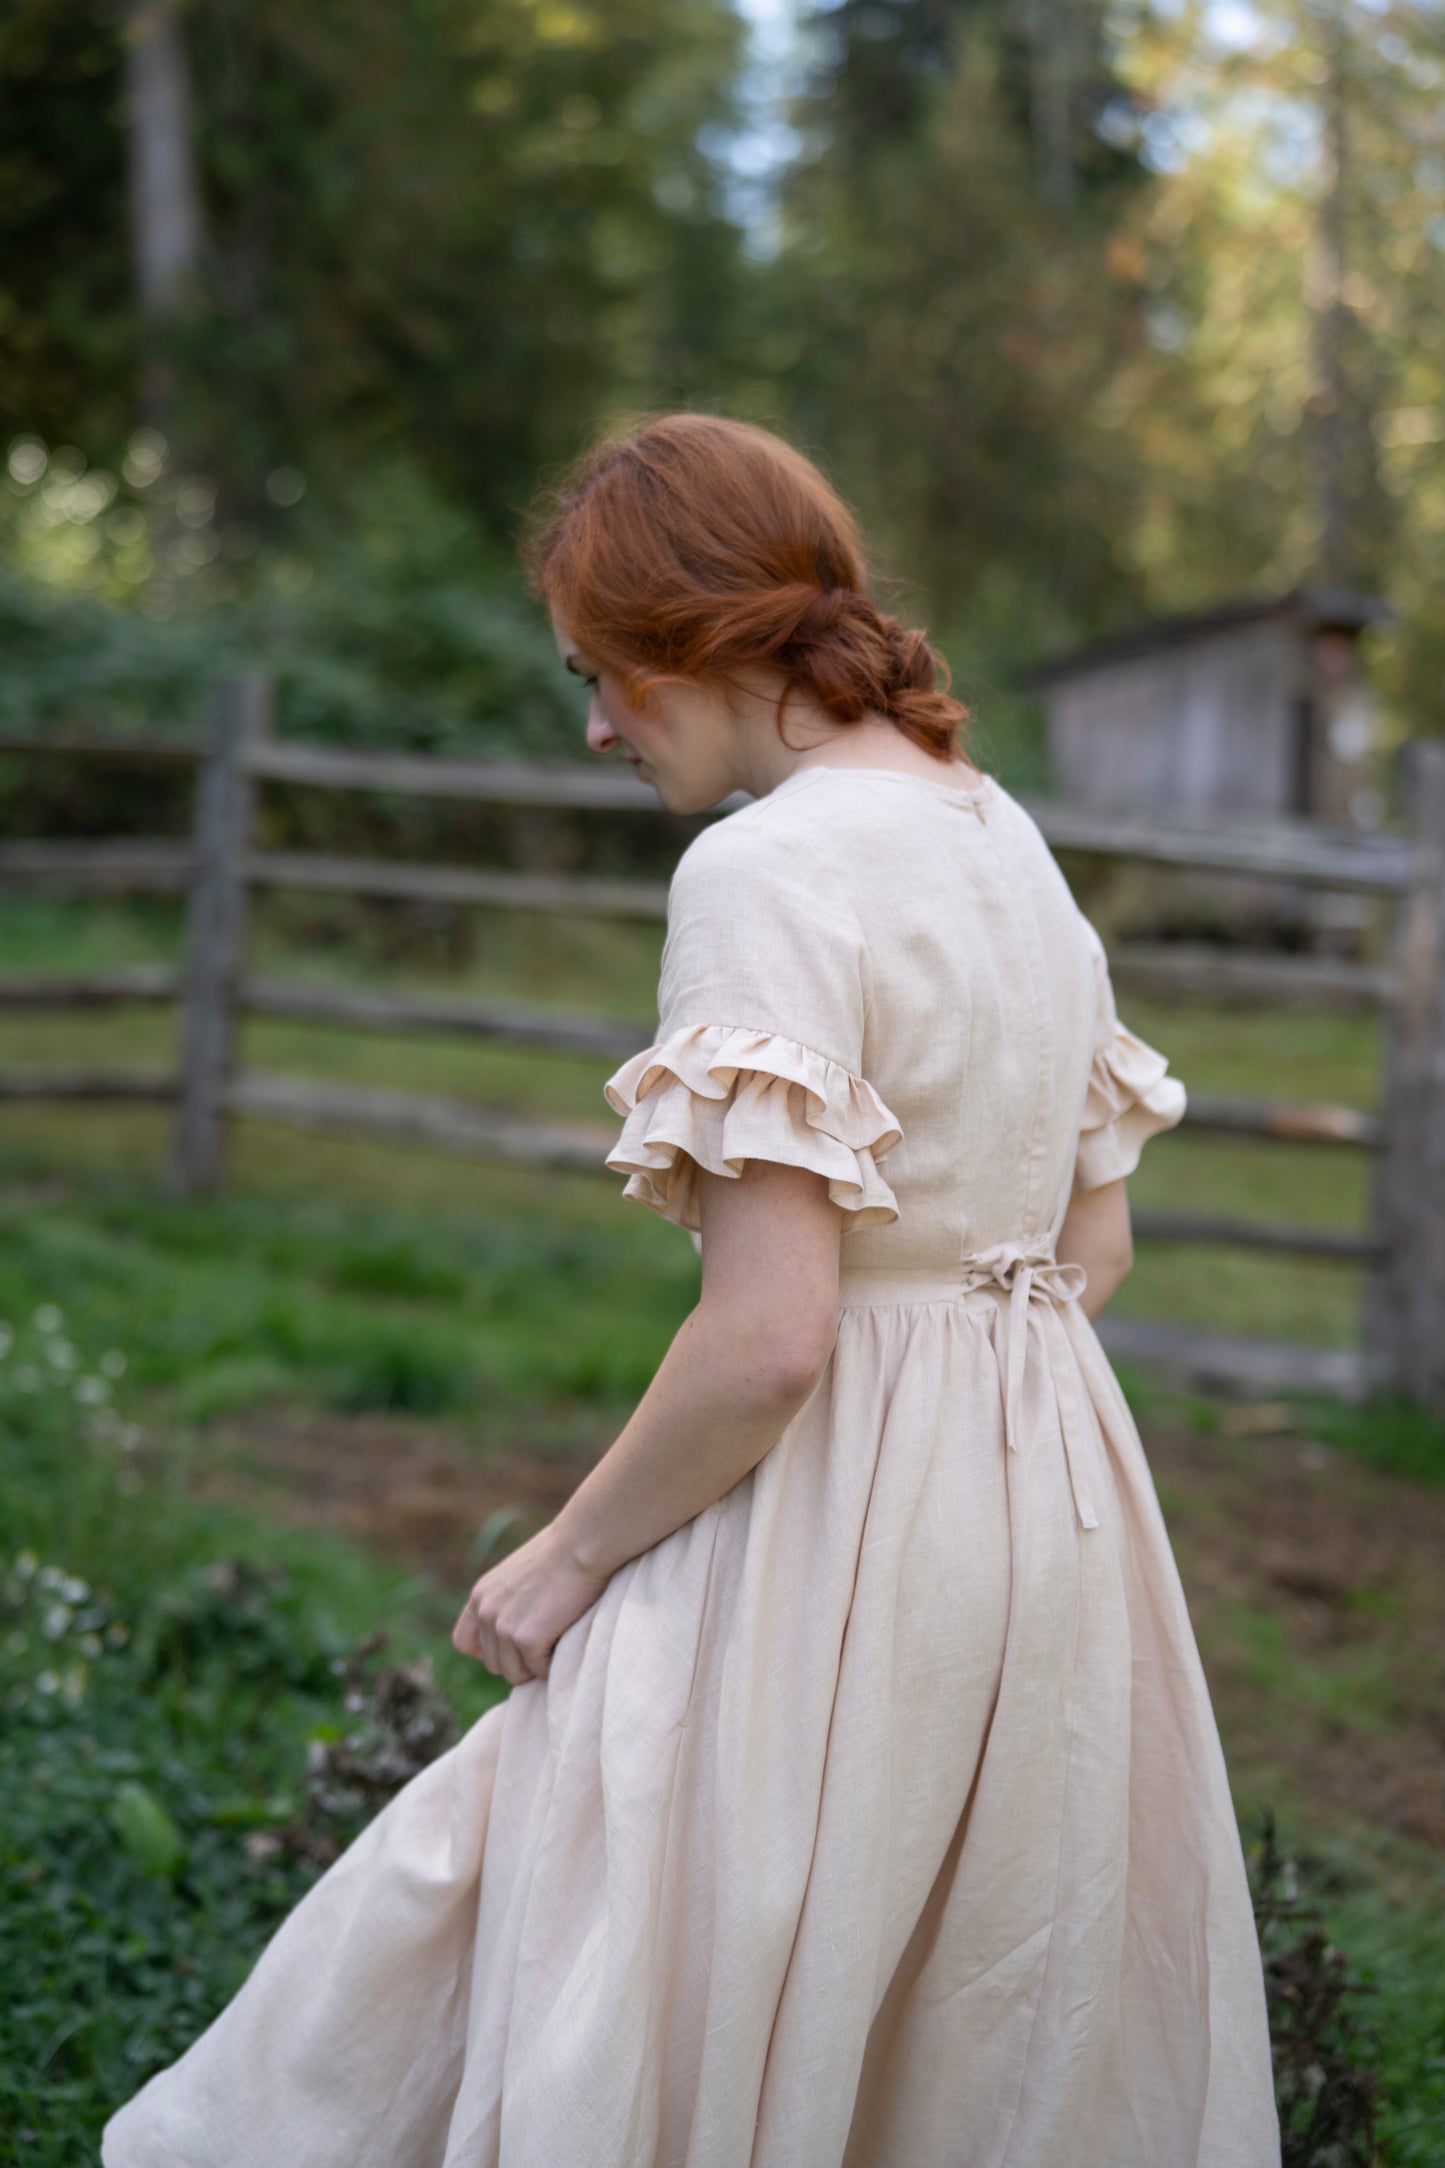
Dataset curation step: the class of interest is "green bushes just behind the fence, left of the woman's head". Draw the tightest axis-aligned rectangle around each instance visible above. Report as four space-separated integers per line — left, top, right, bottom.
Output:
0 455 581 757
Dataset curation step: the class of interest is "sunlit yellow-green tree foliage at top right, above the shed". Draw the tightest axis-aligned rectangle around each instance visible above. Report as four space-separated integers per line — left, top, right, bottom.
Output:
1105 0 1445 728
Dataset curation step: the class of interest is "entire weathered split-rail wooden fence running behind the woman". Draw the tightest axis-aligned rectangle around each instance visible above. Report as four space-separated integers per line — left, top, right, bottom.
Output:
0 676 1445 1411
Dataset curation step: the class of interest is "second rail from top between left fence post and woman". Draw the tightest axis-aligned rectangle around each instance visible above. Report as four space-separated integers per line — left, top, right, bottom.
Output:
245 850 667 919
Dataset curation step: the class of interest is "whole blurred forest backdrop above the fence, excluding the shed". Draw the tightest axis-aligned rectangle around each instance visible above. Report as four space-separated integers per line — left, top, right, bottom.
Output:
0 0 1445 748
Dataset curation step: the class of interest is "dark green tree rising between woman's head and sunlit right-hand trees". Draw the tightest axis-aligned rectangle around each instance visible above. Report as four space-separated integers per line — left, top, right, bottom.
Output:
776 0 1140 620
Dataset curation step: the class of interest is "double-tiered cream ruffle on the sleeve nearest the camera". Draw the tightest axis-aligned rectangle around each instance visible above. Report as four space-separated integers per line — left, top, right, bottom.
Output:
602 1023 903 1234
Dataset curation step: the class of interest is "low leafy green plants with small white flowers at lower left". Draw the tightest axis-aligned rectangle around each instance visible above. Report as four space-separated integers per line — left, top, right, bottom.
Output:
0 1303 503 2168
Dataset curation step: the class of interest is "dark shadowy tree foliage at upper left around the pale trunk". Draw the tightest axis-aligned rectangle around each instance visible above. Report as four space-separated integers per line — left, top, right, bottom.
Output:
0 0 739 515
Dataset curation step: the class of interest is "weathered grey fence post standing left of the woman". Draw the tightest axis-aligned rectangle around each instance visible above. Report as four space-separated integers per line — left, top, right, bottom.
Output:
169 676 273 1197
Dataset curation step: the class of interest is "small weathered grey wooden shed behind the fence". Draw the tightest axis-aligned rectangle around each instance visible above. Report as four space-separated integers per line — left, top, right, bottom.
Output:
1031 588 1389 828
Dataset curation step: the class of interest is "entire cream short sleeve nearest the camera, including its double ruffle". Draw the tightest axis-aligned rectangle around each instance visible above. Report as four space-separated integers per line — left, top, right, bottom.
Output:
602 809 903 1238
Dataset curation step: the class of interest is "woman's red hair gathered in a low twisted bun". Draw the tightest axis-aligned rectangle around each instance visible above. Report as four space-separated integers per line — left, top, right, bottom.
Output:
524 414 968 759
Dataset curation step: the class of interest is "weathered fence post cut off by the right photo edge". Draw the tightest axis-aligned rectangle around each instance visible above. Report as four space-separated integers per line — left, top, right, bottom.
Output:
1365 741 1445 1416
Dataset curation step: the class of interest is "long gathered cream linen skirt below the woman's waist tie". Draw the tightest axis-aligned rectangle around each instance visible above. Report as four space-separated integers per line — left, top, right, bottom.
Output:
102 1270 1280 2168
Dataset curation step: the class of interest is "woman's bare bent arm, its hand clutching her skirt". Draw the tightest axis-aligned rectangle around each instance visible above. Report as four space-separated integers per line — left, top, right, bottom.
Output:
453 1160 843 1685
